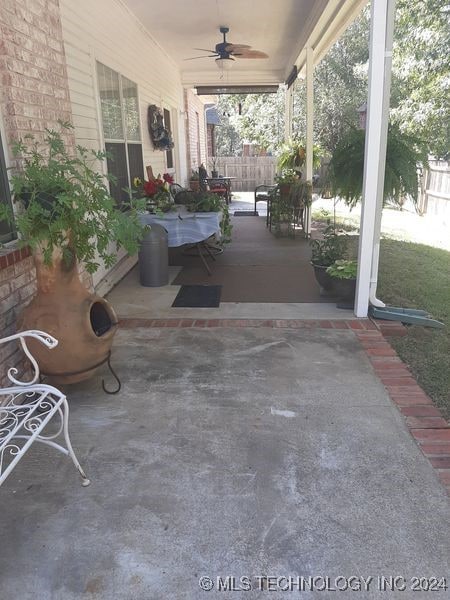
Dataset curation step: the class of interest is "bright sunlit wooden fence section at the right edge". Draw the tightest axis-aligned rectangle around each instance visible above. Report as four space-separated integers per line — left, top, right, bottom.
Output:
418 160 450 222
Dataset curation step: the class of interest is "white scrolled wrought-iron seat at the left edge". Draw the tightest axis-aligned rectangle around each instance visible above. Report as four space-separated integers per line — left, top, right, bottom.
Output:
0 330 90 486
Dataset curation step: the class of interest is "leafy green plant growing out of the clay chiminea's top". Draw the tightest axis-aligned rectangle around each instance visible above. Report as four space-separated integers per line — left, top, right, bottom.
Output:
0 122 144 273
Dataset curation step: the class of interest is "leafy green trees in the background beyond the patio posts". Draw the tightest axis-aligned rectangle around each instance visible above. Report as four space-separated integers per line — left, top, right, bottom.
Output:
213 0 450 157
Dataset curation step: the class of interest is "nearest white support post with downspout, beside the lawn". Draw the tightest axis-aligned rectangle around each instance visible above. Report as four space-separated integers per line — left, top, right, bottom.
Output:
355 0 395 317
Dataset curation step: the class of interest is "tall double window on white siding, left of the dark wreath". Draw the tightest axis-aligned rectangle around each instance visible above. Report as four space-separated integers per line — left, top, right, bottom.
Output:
97 62 144 205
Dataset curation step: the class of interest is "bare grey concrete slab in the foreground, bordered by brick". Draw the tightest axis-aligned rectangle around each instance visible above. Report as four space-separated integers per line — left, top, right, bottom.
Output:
0 327 450 600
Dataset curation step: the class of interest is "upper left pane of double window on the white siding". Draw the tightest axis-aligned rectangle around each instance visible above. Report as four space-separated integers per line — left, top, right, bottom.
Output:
97 63 124 140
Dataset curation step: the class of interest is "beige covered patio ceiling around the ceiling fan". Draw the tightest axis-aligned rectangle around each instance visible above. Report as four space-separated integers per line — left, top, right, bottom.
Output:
123 0 367 87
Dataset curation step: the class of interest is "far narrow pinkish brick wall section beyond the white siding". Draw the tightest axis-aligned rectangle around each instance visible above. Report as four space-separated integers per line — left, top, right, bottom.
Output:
185 90 208 175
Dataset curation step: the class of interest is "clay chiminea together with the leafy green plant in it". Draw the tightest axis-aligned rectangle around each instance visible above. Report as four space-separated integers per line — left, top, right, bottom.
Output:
0 123 143 383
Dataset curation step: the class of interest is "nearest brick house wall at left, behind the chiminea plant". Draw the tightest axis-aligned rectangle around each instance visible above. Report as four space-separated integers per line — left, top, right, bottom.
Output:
0 0 90 385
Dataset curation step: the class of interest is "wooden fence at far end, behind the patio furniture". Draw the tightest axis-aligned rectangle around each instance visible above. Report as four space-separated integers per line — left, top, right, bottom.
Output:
210 156 277 192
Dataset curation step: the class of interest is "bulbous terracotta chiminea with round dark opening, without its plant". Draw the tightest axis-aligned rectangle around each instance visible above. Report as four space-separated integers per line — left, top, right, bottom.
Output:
18 251 117 384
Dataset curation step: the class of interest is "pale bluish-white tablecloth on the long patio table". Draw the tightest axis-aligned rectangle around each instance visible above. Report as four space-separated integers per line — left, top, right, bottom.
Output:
140 207 222 248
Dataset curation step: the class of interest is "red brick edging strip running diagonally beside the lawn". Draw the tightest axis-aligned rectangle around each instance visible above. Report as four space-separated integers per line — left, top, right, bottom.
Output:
355 331 450 495
